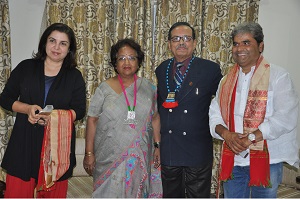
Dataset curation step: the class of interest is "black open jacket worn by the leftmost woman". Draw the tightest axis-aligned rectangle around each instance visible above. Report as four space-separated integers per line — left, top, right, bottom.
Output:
0 59 86 181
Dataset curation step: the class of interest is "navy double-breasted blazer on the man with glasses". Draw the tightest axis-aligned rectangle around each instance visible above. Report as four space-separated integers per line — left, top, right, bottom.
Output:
155 57 222 166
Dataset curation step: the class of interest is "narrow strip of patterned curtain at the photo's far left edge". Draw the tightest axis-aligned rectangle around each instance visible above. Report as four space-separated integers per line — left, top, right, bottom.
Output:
0 0 14 181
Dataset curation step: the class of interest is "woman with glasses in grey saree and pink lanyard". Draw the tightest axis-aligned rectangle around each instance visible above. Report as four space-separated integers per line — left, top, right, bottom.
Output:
83 39 162 198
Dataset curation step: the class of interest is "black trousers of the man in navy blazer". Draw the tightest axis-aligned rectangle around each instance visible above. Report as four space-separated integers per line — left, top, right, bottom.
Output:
161 163 212 198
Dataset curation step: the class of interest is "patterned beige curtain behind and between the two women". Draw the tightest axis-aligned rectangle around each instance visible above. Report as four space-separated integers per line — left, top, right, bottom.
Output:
45 0 154 138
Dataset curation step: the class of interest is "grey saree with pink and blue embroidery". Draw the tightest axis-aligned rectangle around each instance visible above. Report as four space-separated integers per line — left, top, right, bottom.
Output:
93 78 162 198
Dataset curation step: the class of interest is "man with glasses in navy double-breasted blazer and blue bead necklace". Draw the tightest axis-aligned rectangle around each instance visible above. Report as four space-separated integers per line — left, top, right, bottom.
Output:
154 22 222 198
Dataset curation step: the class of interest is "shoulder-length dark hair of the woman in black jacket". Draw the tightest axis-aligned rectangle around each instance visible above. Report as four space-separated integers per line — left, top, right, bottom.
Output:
32 23 77 68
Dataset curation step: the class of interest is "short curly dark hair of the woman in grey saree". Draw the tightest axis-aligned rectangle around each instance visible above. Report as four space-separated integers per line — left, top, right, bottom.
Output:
110 38 145 73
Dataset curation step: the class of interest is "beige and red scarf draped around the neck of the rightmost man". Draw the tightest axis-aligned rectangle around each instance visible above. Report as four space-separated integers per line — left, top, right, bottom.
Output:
219 56 271 187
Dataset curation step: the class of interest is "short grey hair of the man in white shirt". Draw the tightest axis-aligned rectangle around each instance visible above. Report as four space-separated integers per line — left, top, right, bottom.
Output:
231 22 264 44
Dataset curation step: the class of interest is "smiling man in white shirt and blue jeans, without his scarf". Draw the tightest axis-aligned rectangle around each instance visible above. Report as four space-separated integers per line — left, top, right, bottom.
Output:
209 23 299 198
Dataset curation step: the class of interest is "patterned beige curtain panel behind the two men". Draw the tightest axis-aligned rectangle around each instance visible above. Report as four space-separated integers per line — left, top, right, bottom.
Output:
154 0 259 194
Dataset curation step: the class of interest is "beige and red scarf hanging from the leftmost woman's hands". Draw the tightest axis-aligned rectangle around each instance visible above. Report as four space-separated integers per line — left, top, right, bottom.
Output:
37 110 73 191
